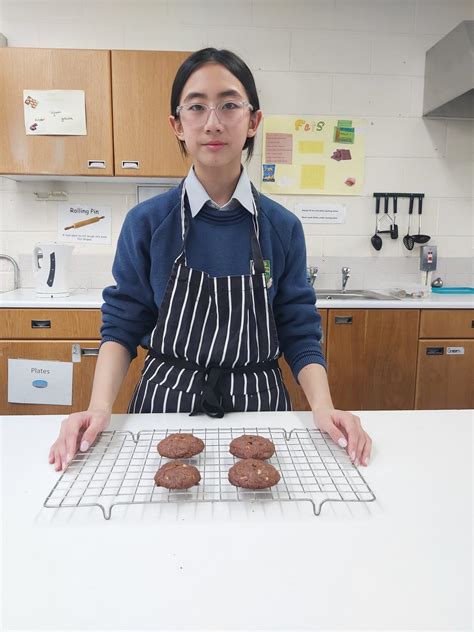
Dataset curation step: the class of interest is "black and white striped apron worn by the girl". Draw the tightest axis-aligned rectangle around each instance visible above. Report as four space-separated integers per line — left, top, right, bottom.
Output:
128 184 291 417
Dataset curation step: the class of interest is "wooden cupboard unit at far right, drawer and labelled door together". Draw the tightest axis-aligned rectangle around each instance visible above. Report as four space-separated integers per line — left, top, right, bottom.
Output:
415 309 474 410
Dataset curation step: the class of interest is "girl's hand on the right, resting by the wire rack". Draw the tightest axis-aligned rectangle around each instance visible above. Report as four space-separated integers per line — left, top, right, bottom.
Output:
313 408 372 466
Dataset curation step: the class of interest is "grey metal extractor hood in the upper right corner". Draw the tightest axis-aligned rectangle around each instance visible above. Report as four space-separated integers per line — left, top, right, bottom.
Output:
423 20 474 119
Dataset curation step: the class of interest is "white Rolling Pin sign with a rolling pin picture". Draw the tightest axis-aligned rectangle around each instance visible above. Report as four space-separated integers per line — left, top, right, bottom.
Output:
58 204 112 245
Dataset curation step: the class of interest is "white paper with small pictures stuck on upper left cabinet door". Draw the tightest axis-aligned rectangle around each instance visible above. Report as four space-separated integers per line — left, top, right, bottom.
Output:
23 90 87 136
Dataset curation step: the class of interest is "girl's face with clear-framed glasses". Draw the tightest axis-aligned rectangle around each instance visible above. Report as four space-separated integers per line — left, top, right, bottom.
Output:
170 63 262 169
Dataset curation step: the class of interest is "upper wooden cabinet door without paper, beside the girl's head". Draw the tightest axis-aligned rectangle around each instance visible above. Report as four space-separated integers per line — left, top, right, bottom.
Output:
112 50 191 177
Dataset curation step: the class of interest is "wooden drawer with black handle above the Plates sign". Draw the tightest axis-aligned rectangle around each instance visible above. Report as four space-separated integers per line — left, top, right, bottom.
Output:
0 308 102 340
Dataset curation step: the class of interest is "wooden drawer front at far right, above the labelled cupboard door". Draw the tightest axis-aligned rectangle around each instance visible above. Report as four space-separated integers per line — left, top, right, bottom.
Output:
420 309 474 338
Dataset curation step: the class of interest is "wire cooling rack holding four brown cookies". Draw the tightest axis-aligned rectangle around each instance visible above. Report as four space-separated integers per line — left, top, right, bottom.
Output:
44 427 375 520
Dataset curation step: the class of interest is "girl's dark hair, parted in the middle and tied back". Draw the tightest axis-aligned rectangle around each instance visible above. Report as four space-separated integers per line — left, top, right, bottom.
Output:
170 48 260 162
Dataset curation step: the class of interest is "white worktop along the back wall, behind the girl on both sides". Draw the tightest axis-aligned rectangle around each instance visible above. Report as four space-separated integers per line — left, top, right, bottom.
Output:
0 288 474 309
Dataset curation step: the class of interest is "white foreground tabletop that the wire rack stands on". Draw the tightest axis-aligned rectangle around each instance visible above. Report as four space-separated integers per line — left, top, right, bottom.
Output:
0 410 474 631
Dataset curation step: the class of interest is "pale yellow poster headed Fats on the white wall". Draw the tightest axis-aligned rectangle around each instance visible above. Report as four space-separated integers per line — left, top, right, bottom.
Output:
261 116 366 195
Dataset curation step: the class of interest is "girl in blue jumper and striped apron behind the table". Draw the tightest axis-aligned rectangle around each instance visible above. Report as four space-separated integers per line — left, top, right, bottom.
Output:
49 48 372 470
